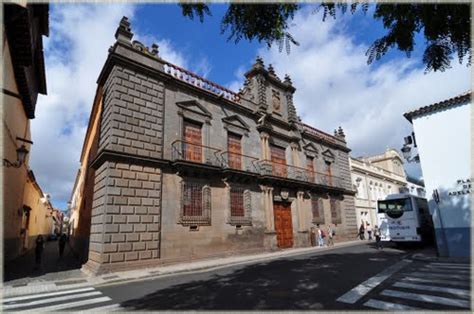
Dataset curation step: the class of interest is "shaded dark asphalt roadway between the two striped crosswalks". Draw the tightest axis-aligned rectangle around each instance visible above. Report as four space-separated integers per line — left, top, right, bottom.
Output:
96 244 416 311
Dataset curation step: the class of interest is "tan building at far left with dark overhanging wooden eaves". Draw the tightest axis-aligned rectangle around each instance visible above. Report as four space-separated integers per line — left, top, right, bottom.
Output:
0 4 48 261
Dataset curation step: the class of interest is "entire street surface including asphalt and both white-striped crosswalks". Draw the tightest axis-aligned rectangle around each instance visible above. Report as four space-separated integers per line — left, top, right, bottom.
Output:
3 243 470 311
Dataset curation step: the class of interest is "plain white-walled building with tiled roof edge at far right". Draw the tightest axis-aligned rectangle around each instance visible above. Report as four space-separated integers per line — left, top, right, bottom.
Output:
404 91 474 256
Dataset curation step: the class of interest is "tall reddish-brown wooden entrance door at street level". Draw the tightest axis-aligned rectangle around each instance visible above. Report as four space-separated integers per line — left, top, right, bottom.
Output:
273 203 293 248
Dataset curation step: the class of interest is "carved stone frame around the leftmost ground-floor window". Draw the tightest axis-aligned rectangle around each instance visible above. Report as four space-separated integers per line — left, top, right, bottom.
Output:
178 178 212 226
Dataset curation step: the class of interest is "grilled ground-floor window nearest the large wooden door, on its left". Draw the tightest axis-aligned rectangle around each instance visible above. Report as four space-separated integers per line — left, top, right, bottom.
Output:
229 186 251 225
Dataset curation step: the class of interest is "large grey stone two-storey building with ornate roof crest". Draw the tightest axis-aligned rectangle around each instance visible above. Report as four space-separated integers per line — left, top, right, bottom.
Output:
77 18 357 273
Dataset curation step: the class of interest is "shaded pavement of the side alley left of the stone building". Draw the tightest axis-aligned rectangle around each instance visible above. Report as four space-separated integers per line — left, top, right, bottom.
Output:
3 241 82 286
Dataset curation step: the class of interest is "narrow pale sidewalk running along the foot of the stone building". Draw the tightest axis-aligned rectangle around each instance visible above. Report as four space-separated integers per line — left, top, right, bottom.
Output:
2 240 367 297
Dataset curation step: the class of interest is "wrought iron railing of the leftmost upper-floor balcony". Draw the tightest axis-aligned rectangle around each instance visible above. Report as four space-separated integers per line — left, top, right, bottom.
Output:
171 140 222 167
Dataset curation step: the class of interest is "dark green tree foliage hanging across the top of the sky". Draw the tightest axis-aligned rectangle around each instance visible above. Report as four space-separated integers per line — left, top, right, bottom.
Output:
180 2 471 72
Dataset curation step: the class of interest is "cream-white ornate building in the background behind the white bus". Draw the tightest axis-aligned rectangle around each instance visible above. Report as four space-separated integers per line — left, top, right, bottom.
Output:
350 149 407 226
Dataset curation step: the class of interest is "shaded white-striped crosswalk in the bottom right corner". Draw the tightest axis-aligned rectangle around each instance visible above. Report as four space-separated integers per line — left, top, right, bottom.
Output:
362 263 471 311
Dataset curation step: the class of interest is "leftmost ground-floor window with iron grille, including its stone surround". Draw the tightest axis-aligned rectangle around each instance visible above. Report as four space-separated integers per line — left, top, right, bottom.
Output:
180 180 211 225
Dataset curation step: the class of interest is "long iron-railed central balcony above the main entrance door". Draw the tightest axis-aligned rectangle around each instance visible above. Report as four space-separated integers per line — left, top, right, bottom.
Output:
260 160 344 189
